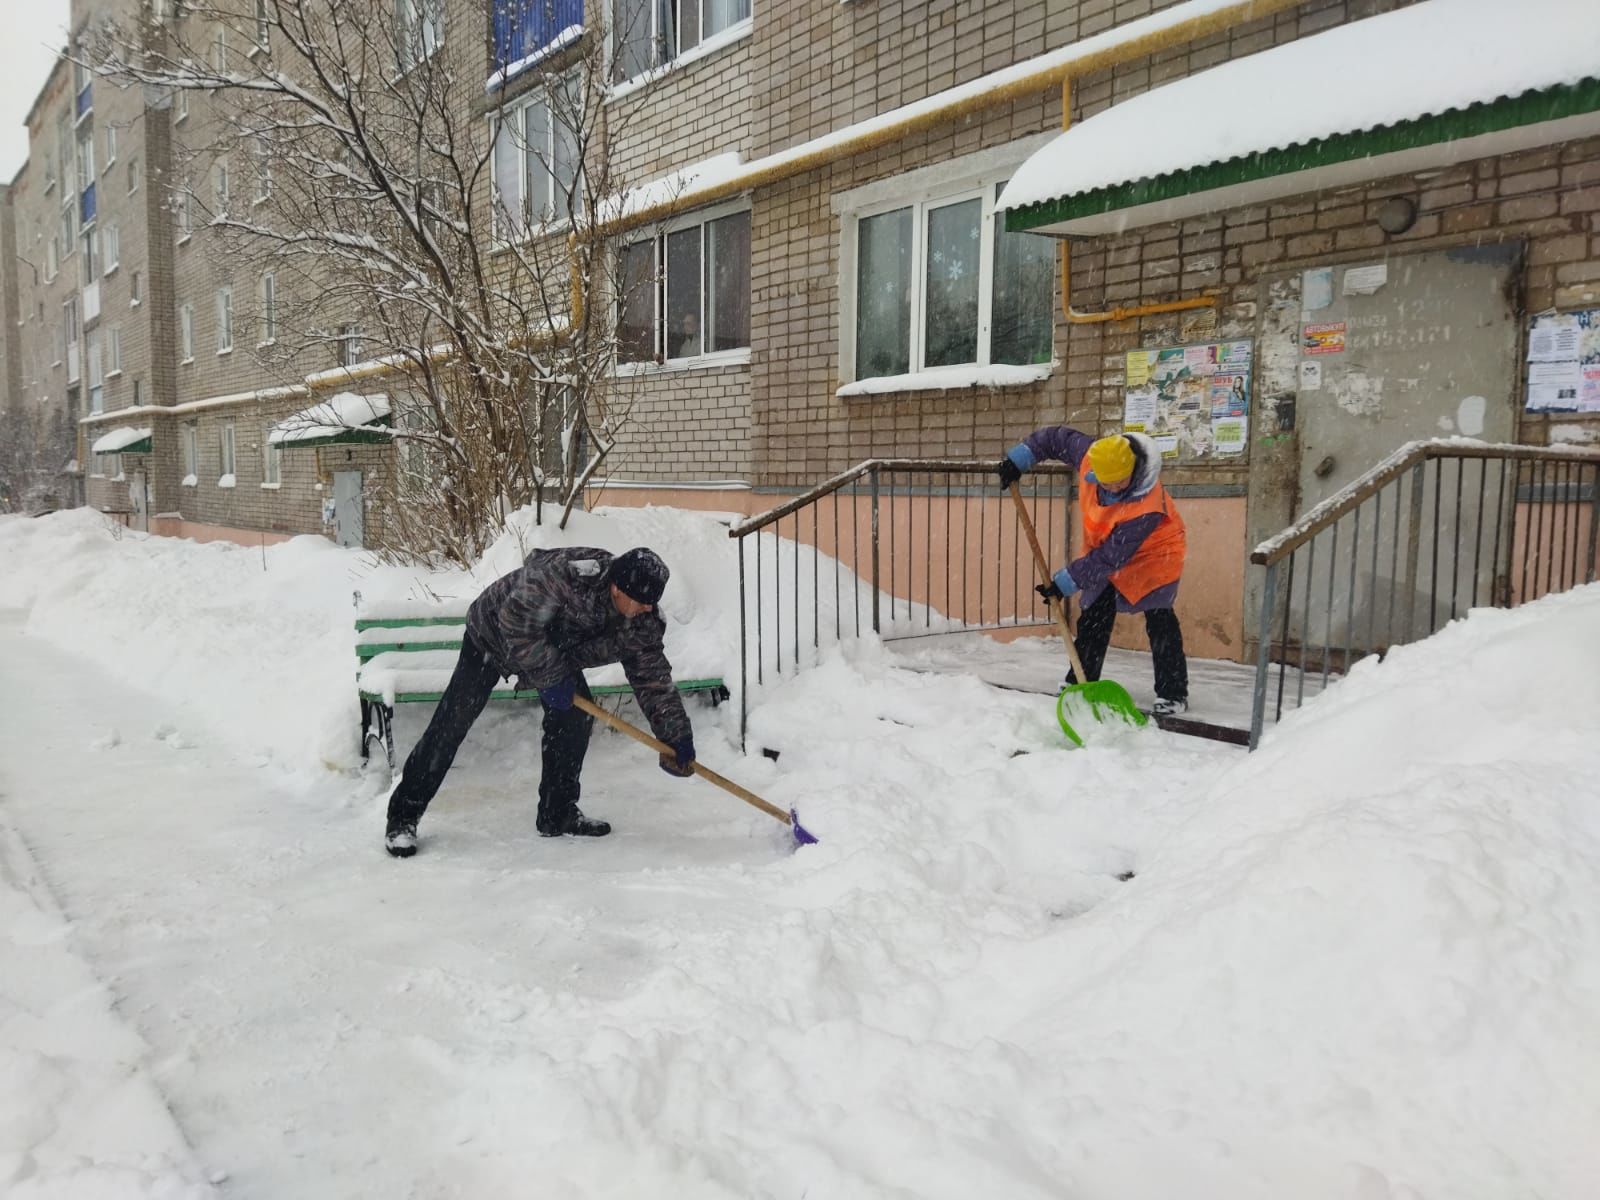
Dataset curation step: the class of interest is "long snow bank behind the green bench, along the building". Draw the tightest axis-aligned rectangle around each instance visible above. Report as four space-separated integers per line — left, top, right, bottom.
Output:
0 507 738 781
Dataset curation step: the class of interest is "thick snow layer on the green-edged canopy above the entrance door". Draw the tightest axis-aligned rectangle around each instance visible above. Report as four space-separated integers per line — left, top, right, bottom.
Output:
1000 0 1600 210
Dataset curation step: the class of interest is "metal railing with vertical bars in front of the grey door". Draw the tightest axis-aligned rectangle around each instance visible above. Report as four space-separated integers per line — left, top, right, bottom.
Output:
1250 440 1600 749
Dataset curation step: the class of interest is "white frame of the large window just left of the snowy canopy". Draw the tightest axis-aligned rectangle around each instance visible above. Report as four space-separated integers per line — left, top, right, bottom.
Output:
838 168 1054 384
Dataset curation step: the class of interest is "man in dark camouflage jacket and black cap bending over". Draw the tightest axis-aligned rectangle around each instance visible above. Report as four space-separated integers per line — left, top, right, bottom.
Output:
384 546 694 858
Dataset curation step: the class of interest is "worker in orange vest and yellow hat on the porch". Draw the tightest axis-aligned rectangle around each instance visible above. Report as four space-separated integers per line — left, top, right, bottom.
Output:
995 426 1189 717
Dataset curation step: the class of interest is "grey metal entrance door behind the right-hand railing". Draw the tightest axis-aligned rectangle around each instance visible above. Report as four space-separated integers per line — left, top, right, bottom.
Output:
1246 243 1522 650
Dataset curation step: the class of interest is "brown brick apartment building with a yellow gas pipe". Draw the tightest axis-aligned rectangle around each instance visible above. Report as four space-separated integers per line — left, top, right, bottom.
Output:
3 0 1600 658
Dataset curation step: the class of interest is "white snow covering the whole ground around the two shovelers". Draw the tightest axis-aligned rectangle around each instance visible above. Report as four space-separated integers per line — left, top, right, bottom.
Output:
0 510 1600 1200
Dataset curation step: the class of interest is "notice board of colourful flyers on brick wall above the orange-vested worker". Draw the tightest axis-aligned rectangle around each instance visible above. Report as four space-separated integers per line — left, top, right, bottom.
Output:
1122 339 1253 462
